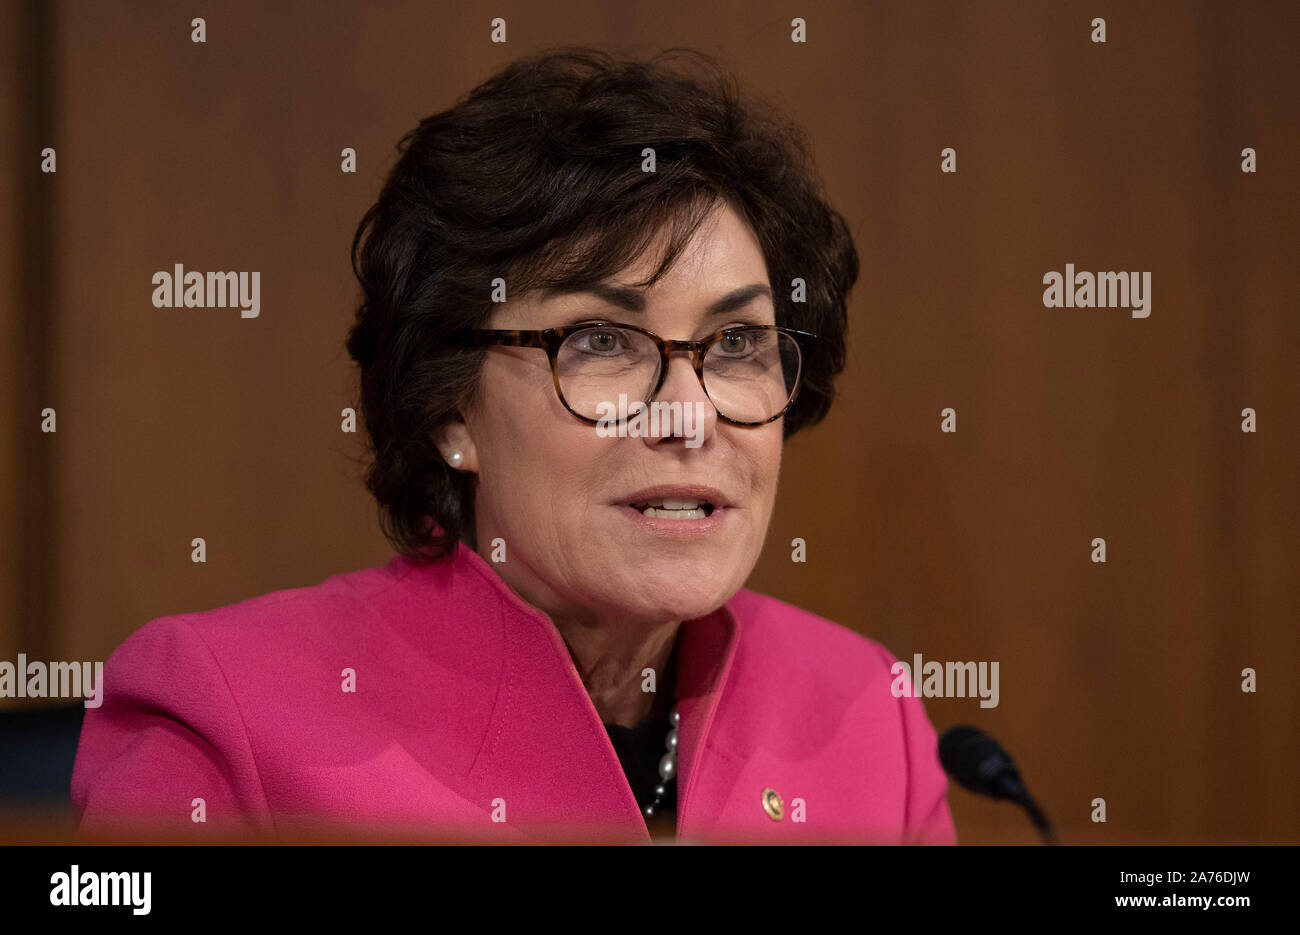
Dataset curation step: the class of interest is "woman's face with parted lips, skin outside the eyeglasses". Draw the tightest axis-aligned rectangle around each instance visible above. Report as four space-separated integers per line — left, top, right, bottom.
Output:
445 203 783 623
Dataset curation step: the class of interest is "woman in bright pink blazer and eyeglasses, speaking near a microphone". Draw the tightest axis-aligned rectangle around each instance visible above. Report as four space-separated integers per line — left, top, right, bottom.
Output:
73 49 954 843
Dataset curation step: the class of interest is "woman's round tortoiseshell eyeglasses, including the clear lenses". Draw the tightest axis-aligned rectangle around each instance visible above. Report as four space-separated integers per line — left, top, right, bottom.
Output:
456 321 816 425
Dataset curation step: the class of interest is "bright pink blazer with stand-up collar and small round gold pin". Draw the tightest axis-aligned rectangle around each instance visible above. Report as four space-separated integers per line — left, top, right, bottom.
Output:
72 545 956 844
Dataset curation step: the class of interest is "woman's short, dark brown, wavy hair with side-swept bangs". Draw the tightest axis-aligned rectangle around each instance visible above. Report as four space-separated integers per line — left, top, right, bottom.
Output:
347 47 858 562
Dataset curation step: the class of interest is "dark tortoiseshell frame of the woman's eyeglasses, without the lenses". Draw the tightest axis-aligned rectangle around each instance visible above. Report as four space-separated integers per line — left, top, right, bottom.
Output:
451 321 816 425
